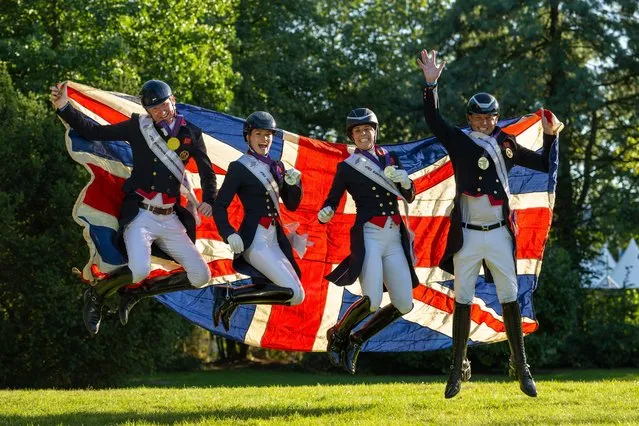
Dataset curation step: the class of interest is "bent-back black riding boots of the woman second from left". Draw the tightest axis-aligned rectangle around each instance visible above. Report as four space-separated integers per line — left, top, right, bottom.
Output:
212 283 293 331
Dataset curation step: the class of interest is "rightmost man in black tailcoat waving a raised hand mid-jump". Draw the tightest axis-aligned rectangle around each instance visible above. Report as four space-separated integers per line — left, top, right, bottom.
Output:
417 50 563 398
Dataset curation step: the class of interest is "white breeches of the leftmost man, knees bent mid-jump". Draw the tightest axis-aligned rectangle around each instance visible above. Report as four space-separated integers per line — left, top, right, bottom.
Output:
124 209 211 288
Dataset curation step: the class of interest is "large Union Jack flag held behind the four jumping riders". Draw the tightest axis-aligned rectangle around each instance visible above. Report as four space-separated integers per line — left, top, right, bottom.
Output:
66 82 557 352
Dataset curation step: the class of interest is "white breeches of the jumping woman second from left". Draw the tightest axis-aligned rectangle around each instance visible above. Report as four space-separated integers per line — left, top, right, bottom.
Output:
242 225 304 306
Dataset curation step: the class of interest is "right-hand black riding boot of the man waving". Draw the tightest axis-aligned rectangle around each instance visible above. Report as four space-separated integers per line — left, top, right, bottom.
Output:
501 301 537 397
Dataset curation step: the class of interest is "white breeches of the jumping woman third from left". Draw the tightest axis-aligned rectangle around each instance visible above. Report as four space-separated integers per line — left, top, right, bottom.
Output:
359 218 413 314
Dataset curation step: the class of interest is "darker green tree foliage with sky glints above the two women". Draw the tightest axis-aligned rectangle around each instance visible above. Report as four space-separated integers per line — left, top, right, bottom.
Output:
233 0 434 143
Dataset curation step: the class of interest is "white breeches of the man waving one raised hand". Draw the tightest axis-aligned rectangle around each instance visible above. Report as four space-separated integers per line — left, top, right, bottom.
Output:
453 226 517 305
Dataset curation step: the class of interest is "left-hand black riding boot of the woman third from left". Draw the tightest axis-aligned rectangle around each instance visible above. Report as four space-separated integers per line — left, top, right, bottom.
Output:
326 296 371 367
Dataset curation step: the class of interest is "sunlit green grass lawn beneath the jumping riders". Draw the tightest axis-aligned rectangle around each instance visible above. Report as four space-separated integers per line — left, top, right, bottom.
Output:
0 367 639 425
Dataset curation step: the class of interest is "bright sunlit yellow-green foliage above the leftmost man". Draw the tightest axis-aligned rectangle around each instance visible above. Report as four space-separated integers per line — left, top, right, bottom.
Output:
0 0 238 109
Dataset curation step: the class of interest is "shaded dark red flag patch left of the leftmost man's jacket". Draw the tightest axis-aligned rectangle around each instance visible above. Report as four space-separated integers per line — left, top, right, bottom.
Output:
84 164 124 217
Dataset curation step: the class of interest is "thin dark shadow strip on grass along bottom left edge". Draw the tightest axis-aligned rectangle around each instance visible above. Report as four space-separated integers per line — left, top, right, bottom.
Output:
0 405 370 425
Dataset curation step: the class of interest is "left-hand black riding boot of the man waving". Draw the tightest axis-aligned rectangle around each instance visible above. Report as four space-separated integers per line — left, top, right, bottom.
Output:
444 302 471 398
